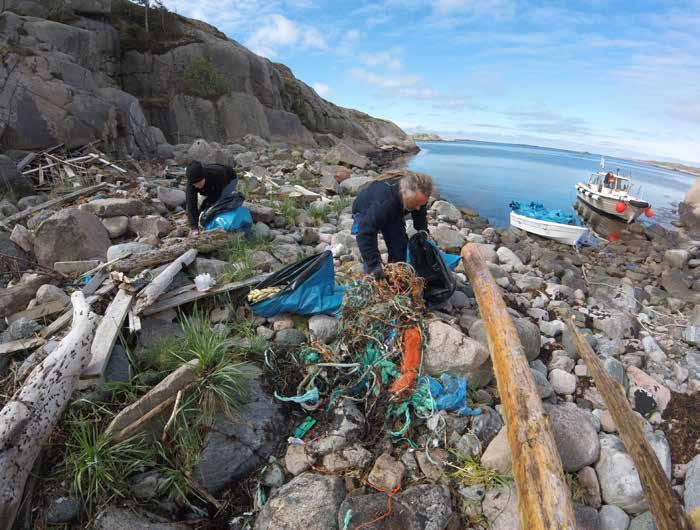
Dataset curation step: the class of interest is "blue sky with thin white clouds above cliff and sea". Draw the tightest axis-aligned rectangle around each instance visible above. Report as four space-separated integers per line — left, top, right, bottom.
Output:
164 0 700 164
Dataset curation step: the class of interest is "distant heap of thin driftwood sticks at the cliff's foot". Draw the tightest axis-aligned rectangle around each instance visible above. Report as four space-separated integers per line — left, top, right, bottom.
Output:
17 142 127 191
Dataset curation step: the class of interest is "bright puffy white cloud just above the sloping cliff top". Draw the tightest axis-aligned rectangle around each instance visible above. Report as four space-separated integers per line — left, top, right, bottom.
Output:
246 14 326 57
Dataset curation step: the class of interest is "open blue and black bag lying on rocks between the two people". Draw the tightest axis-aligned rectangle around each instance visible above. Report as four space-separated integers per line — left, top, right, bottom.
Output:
250 251 346 318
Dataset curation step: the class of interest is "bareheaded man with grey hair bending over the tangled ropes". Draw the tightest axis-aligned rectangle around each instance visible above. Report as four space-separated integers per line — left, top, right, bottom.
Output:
352 171 433 279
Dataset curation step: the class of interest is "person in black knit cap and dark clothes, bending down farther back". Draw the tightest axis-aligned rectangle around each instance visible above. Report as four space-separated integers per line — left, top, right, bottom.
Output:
186 160 236 235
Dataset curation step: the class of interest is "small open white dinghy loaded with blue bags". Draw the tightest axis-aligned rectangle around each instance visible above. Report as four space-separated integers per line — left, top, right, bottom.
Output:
510 201 589 245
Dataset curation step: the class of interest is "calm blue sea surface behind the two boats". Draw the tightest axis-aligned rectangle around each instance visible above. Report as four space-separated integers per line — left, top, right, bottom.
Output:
409 141 695 227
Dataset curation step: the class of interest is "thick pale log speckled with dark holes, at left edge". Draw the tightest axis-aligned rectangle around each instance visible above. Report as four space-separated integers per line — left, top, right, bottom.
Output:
0 292 97 529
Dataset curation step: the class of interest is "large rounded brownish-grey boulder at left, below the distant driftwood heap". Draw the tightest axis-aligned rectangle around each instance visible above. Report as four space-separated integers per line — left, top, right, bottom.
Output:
34 209 111 269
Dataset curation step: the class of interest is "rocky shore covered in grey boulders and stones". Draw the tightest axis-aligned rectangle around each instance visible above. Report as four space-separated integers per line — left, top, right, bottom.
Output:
0 135 700 530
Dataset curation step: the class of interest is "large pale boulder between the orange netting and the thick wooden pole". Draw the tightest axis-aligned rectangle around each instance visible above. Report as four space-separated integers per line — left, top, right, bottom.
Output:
423 320 489 379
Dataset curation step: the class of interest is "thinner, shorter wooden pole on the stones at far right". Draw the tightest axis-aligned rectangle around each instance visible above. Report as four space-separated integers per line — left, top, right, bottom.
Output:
566 319 690 530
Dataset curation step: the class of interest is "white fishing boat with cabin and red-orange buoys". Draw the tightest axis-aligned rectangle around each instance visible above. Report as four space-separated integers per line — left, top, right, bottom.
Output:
576 159 654 224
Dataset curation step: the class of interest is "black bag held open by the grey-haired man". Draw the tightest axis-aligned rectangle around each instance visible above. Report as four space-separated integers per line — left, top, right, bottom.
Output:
408 232 457 305
